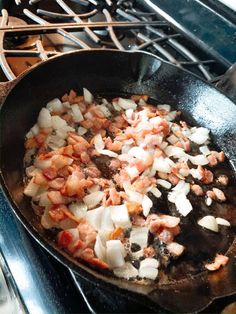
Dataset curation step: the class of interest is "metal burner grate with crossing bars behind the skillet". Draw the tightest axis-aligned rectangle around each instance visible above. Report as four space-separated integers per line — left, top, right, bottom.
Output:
0 0 230 82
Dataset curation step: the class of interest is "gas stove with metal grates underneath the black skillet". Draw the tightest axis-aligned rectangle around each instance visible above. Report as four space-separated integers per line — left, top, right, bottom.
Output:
0 0 236 314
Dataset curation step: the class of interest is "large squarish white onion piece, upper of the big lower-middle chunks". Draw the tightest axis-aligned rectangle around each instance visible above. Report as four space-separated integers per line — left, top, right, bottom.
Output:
110 204 131 228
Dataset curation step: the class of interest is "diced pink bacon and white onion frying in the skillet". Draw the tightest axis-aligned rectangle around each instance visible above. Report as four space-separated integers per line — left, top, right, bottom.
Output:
24 89 230 280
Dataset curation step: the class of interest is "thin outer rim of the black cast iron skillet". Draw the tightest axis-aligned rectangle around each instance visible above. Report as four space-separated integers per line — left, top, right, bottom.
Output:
0 48 236 310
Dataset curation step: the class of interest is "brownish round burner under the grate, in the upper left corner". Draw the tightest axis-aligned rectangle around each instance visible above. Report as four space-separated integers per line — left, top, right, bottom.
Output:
0 16 40 49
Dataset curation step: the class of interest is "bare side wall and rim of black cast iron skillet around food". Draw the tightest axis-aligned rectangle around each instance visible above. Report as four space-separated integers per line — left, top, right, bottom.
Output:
0 50 236 312
